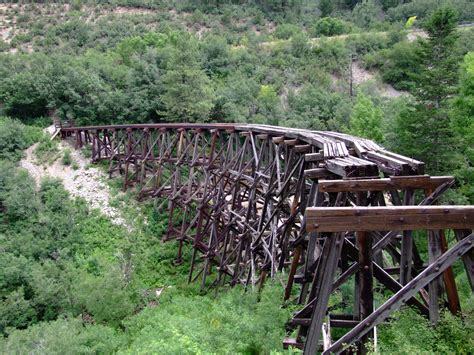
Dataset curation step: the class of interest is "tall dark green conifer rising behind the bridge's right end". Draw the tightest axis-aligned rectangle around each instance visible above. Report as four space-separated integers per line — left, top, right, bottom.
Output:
397 7 458 173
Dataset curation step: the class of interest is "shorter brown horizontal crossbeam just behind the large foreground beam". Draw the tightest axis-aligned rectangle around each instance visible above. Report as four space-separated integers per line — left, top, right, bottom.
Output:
319 175 454 192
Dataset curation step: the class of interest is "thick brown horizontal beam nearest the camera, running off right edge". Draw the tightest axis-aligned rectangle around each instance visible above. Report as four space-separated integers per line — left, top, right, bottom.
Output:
306 206 474 232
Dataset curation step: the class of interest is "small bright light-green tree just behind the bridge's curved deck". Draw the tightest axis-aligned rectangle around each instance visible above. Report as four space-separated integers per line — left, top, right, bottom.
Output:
349 93 384 142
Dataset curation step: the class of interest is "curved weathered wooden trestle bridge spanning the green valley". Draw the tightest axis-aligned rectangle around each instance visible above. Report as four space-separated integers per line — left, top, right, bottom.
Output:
61 124 474 354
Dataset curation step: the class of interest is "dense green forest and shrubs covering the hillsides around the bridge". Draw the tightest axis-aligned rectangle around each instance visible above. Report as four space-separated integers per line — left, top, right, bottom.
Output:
0 0 474 354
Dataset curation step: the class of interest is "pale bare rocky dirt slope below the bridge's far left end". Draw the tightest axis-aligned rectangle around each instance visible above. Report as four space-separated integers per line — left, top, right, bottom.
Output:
20 127 127 226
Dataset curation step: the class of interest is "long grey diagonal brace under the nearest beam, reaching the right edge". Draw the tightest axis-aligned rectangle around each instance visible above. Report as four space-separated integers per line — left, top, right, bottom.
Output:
323 233 474 355
